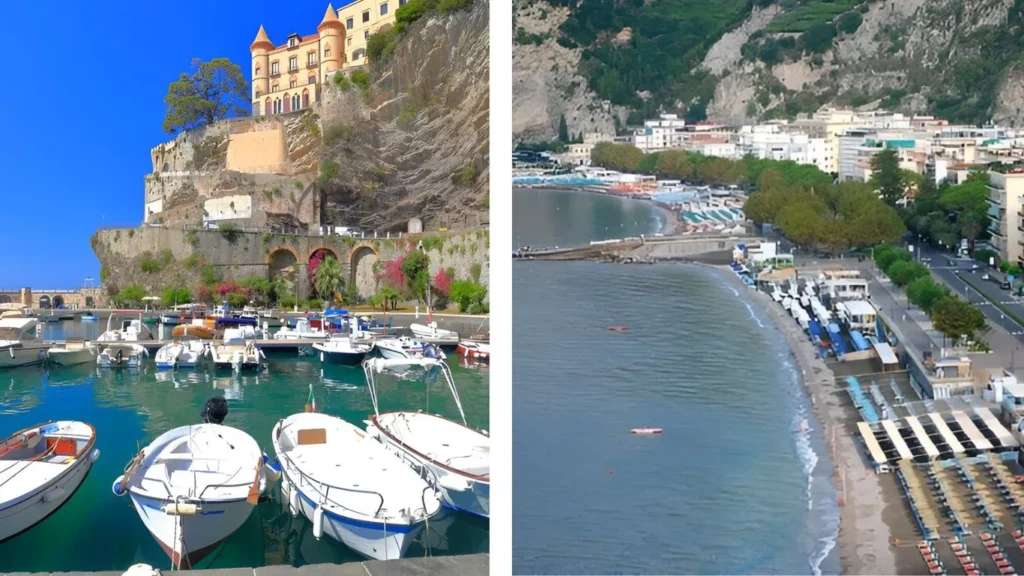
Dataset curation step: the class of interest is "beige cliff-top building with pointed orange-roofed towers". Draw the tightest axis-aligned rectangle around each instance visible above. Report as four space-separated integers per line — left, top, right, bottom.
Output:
249 0 408 116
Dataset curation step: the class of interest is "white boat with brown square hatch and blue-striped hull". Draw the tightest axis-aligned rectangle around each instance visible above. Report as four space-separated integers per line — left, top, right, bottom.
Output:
271 412 441 560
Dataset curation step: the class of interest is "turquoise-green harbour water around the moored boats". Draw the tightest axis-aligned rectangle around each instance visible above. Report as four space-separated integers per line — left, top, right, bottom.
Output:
0 322 489 572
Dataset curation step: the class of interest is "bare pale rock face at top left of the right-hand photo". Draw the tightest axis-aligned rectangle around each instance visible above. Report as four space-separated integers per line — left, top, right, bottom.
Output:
512 0 625 142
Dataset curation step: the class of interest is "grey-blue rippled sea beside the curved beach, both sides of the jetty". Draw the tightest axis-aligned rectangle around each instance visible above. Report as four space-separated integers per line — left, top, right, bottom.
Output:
513 191 839 574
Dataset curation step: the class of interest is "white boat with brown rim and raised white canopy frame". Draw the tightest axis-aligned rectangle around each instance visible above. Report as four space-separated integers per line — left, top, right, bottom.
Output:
362 358 490 518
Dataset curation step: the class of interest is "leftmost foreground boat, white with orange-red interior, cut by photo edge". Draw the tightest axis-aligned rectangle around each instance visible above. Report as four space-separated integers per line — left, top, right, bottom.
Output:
0 420 99 542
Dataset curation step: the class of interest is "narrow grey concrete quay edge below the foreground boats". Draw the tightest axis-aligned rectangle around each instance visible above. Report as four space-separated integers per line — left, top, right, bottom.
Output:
0 554 490 576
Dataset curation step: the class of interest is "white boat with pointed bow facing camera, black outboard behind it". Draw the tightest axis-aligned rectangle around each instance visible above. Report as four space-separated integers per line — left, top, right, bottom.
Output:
114 399 266 569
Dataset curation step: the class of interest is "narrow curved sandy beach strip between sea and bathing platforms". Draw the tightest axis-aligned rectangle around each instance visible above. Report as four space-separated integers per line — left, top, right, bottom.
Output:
708 266 901 574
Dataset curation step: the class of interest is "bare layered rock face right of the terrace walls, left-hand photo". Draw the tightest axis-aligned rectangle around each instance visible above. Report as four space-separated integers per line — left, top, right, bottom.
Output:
318 0 490 231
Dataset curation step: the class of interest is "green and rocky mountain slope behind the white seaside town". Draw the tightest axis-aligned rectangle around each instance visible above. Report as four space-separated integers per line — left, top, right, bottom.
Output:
513 0 1024 130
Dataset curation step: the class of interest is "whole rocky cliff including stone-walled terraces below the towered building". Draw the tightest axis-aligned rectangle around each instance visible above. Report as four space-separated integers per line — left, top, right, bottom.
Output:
144 0 489 233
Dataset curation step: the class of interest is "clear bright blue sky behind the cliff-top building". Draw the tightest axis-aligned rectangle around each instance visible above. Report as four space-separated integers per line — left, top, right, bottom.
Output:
0 0 349 290
